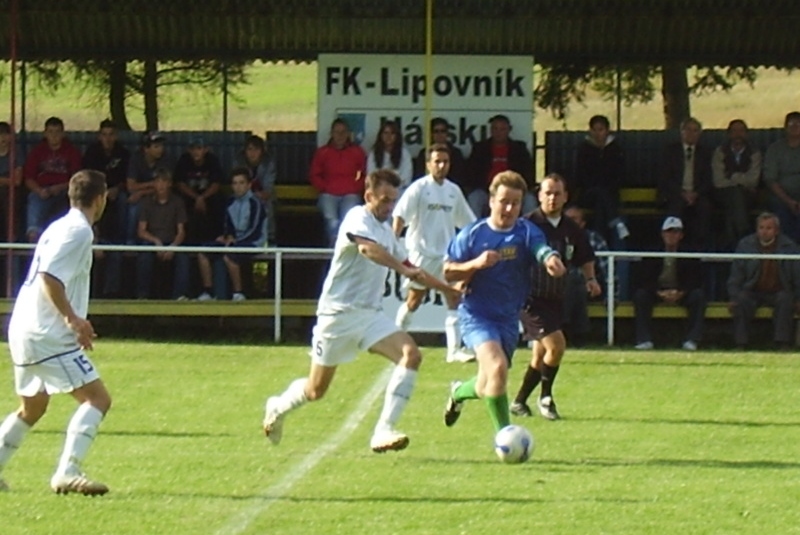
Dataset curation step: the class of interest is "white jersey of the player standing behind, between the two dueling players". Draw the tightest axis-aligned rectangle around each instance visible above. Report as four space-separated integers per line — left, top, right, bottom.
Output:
393 175 475 257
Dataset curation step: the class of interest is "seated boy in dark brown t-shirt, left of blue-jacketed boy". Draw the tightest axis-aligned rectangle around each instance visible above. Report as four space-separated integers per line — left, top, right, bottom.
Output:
136 168 189 300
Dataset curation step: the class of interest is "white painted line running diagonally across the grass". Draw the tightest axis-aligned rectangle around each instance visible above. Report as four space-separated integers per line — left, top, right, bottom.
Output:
217 366 394 535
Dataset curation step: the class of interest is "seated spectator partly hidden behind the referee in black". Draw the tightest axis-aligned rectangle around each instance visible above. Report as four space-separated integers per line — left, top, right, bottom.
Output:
564 206 619 347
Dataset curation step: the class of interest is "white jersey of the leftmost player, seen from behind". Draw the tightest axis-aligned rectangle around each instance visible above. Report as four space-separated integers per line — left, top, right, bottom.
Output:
8 208 94 365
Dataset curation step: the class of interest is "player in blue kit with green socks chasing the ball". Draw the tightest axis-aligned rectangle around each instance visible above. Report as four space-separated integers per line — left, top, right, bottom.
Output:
444 171 566 431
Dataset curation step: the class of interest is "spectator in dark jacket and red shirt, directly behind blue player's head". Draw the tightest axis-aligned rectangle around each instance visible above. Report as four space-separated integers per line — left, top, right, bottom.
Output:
467 115 537 218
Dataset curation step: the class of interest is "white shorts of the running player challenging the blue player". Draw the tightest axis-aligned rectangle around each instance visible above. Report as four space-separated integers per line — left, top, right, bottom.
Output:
309 310 400 366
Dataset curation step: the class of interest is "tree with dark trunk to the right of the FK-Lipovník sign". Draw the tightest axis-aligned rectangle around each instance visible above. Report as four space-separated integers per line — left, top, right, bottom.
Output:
534 62 756 129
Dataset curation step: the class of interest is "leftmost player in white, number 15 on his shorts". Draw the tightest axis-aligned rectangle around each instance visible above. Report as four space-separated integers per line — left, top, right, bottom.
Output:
0 170 111 495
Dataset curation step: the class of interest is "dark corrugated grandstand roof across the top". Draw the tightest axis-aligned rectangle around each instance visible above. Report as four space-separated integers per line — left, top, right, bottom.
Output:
0 0 800 66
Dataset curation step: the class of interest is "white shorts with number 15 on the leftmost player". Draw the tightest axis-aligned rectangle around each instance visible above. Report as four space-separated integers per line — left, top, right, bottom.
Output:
14 351 100 397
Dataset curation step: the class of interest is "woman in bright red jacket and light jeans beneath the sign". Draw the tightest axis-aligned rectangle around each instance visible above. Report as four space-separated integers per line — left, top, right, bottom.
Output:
309 119 367 247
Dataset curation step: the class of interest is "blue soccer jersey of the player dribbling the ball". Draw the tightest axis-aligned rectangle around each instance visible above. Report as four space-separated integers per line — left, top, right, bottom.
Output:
447 219 557 324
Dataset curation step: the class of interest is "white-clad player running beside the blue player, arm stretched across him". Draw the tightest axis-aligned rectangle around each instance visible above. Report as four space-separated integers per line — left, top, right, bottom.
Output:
264 169 454 453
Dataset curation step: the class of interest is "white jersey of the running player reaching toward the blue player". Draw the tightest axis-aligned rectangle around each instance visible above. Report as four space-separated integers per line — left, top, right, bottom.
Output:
317 205 408 314
